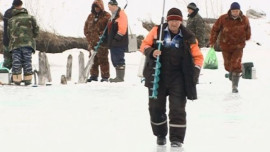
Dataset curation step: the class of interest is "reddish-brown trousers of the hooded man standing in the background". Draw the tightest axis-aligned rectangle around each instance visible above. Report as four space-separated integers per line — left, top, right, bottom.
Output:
90 47 110 79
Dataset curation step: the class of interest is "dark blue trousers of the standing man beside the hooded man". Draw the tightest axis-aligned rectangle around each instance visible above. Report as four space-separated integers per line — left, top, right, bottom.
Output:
110 47 126 67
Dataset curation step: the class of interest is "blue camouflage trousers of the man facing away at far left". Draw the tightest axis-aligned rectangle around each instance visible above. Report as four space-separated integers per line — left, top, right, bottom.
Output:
12 47 33 75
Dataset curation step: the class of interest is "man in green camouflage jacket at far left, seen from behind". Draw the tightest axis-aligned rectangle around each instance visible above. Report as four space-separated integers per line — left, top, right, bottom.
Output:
7 0 39 85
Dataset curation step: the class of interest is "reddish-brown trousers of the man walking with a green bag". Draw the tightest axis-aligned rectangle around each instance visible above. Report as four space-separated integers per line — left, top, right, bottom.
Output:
222 49 243 73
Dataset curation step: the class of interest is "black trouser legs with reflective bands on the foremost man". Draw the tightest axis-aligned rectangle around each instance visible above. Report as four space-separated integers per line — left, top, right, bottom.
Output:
149 82 186 143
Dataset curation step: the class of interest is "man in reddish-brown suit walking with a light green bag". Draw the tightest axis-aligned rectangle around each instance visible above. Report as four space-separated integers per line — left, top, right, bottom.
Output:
210 2 251 93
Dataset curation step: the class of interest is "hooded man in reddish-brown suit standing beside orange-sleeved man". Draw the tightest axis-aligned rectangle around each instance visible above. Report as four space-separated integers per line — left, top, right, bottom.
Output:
84 0 111 82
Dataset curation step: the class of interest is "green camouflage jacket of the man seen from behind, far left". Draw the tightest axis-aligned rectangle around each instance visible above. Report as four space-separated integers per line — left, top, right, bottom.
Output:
7 8 39 51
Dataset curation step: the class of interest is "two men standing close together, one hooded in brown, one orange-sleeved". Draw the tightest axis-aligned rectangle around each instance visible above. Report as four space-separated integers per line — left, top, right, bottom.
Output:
84 0 128 82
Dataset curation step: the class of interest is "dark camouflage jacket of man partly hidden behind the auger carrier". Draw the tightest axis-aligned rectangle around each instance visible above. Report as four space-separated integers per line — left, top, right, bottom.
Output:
186 11 205 48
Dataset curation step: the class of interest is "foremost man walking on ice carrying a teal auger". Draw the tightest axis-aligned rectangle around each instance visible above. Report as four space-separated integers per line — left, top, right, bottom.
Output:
140 8 203 147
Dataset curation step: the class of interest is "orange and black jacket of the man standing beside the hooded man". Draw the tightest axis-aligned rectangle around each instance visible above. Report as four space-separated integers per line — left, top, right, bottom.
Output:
107 7 128 48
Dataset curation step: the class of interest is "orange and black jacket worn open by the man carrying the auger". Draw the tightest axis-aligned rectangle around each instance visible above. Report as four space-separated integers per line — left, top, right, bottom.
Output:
140 24 203 100
